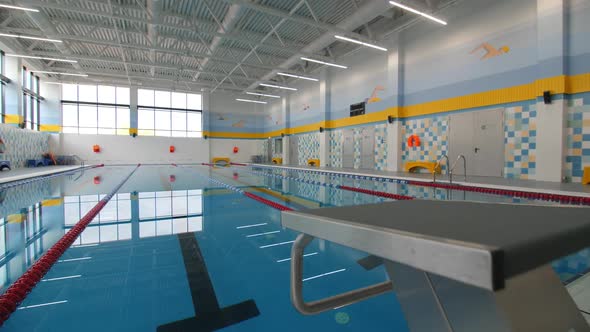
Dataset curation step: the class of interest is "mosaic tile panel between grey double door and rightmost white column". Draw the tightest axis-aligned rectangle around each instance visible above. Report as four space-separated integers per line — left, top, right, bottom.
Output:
504 105 537 180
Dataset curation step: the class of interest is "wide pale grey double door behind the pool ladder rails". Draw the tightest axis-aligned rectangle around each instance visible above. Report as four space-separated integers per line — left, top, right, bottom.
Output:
449 109 504 177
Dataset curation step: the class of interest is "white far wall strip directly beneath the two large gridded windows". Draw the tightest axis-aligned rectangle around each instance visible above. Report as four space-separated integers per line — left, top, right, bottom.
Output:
60 134 209 165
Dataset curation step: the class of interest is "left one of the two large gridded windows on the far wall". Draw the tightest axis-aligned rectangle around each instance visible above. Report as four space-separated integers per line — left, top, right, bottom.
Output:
62 84 131 135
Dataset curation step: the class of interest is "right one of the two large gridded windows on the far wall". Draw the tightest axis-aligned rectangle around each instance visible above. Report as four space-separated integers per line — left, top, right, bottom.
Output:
137 89 202 137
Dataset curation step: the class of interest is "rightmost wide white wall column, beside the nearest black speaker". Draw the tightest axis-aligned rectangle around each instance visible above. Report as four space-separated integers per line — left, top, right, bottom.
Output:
535 0 567 182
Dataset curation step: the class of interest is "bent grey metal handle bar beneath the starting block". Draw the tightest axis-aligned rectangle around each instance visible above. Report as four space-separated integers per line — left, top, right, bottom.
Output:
291 234 393 315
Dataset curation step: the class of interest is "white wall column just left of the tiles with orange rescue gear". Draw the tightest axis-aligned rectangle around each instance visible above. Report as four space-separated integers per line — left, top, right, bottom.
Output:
386 33 404 172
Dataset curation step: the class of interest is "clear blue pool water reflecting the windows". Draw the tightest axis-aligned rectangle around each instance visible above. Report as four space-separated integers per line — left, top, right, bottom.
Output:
0 166 590 332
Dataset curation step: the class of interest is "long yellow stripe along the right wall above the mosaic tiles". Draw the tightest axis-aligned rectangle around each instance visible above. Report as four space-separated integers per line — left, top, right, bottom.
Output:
205 73 590 139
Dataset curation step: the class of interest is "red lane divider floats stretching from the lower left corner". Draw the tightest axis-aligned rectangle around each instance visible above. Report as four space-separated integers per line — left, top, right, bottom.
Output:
0 165 139 326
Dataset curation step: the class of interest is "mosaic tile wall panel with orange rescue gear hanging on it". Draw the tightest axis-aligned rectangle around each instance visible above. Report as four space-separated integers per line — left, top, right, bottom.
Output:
402 116 449 169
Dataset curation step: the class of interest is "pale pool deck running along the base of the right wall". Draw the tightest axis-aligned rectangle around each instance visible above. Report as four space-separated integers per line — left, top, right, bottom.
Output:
247 164 590 197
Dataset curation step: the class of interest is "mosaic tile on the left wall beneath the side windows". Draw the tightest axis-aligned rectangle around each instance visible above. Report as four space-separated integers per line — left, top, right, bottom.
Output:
0 124 50 168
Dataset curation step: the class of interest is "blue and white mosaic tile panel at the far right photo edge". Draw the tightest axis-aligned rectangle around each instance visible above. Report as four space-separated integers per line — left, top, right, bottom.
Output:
565 98 590 183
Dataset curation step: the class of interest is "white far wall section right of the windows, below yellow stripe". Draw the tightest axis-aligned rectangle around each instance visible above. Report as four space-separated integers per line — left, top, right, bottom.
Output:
207 138 264 162
